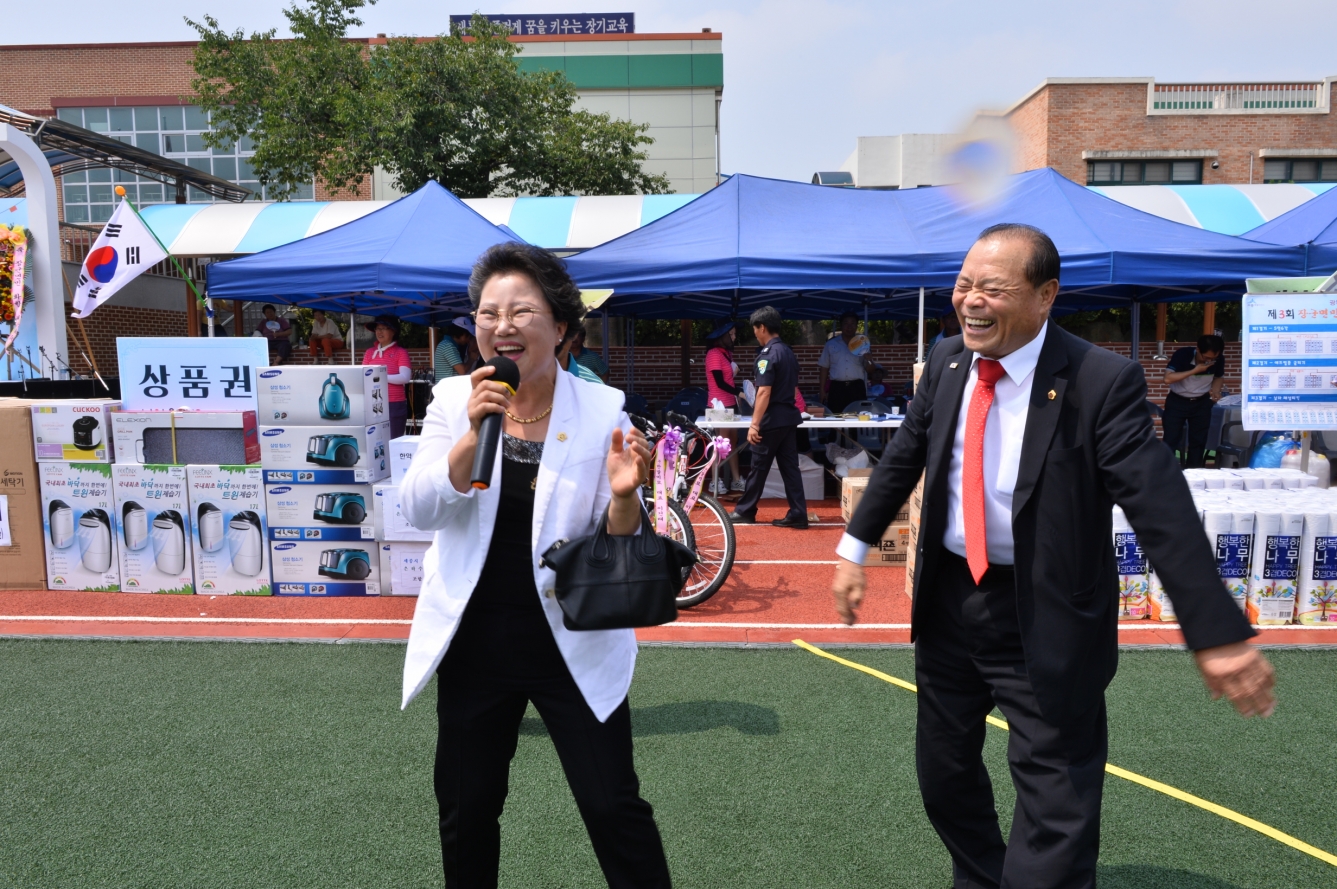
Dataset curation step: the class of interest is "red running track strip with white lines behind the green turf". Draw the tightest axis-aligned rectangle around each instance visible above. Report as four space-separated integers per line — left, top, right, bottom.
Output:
0 500 1337 646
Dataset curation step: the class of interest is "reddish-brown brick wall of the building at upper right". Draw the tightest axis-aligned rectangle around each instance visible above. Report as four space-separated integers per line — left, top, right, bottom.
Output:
1008 83 1337 184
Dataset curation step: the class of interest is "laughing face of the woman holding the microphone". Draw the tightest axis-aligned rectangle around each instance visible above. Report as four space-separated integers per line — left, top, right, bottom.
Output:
477 273 567 380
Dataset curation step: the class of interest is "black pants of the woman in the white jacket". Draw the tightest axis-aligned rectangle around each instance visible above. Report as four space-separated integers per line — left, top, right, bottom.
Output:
435 667 670 889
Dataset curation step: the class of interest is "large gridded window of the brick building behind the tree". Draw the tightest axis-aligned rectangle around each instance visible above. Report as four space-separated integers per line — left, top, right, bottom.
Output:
56 106 316 223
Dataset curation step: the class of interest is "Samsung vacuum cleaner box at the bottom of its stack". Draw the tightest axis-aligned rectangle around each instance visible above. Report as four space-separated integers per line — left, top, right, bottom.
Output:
269 540 381 596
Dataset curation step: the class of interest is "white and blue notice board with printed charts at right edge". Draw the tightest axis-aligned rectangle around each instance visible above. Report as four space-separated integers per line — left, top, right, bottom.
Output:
1241 278 1337 430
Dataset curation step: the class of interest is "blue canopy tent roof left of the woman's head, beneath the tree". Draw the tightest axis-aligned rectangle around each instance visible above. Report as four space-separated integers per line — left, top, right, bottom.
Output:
207 182 519 324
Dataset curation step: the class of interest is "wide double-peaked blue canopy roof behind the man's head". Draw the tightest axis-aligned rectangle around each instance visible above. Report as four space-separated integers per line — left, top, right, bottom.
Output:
568 168 1304 318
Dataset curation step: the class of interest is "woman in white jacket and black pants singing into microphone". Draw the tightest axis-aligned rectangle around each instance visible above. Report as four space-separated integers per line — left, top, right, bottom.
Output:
400 243 670 889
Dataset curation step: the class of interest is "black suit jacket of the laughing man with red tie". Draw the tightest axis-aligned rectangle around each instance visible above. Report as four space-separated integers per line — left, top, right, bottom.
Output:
849 324 1253 722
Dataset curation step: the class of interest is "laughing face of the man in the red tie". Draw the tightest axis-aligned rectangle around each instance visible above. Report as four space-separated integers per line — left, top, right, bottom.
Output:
952 235 1059 358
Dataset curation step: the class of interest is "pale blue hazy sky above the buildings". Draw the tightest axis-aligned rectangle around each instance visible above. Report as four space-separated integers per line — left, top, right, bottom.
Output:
3 0 1337 182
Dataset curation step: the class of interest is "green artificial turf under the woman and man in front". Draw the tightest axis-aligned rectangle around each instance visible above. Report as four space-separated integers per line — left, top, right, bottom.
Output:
0 640 1337 889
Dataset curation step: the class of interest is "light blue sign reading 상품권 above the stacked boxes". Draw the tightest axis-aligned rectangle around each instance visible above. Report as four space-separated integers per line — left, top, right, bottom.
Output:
116 337 269 410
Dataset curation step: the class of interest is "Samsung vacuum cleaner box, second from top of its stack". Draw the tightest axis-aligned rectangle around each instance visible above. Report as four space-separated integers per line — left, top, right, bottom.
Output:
259 422 390 484
